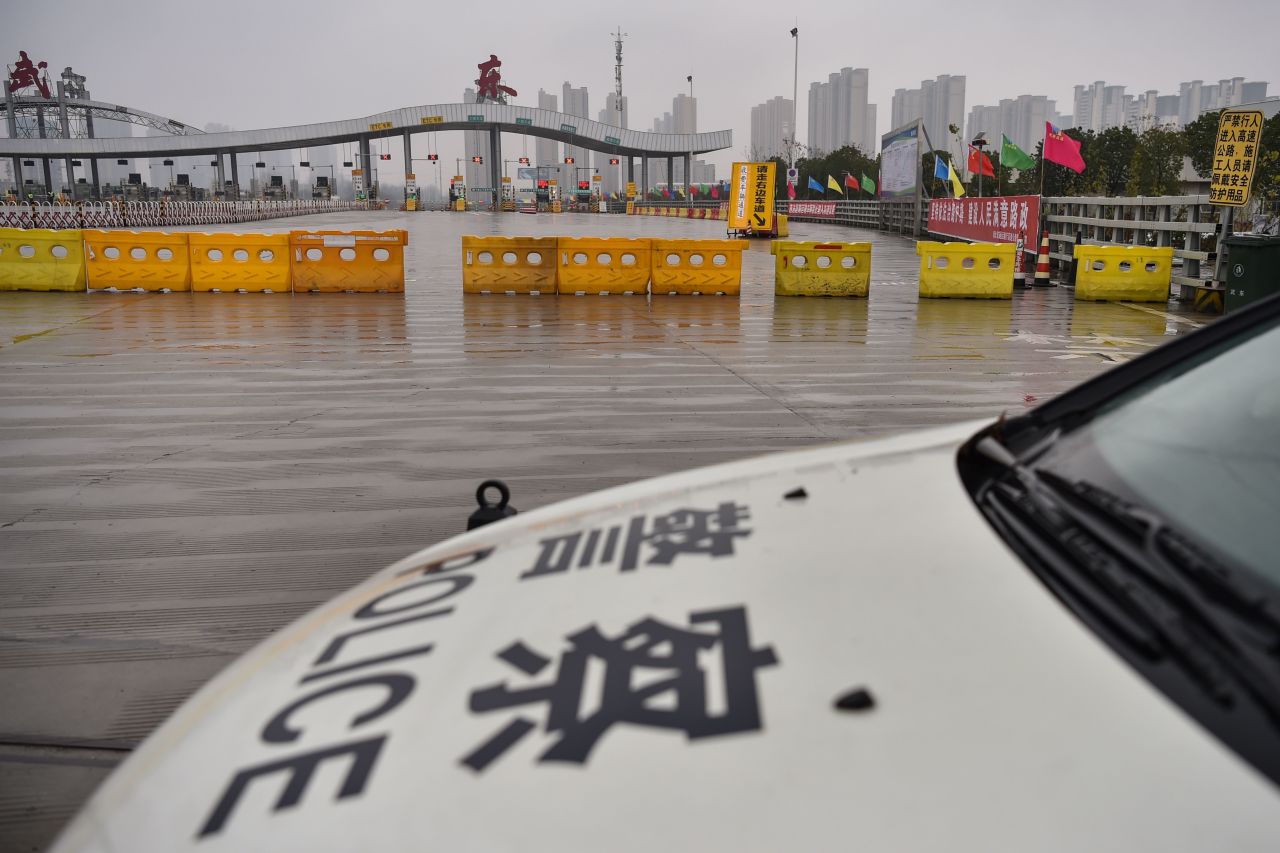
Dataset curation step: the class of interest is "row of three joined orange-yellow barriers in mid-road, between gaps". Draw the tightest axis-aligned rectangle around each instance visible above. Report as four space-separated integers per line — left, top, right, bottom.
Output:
462 237 746 296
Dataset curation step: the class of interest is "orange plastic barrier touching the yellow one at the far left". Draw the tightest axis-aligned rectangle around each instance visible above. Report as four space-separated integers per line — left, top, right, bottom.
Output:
82 229 191 292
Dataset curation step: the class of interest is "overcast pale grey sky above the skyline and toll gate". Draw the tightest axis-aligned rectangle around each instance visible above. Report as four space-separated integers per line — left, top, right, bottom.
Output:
0 0 1280 174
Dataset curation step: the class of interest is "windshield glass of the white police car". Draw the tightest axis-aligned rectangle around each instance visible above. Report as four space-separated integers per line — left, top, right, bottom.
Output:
1036 312 1280 587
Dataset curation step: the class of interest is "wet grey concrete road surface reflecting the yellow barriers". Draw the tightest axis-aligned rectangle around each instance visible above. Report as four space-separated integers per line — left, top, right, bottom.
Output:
0 213 1203 850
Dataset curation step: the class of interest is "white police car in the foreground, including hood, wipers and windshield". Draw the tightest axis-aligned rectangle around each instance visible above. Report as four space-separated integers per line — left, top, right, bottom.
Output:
56 300 1280 853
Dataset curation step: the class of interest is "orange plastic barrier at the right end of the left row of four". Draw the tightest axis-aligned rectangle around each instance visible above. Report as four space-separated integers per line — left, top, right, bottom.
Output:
289 231 408 293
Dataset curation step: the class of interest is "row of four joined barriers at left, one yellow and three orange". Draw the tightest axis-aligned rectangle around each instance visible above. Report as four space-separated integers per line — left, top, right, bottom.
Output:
0 228 408 293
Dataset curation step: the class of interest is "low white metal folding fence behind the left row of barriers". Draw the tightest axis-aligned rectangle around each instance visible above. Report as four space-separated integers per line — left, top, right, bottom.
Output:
0 199 369 229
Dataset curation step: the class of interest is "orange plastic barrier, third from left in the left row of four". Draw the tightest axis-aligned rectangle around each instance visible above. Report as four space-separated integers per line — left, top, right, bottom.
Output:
187 234 293 293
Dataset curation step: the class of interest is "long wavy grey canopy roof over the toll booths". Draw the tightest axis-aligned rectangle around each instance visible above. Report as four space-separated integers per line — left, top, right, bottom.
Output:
0 99 733 202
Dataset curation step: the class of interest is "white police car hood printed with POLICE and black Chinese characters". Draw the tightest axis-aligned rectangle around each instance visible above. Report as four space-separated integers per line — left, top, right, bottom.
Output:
56 424 1280 853
